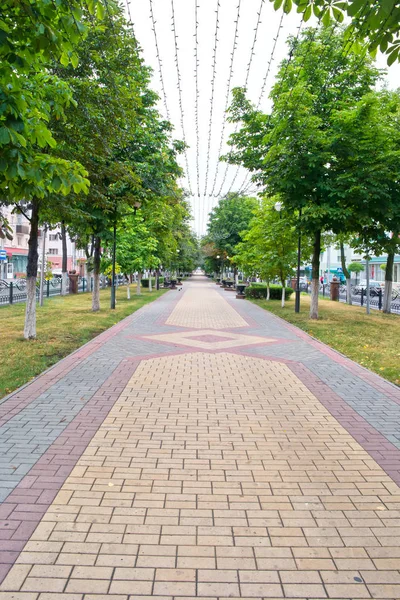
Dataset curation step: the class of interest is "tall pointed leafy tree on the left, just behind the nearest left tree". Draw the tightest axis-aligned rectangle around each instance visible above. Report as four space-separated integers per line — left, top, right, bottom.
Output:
49 6 183 311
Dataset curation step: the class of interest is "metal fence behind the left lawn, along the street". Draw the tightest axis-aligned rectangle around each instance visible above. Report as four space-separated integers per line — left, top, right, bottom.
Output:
0 277 123 306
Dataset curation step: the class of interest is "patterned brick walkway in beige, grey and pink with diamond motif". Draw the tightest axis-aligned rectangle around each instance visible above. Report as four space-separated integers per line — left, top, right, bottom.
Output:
0 277 400 600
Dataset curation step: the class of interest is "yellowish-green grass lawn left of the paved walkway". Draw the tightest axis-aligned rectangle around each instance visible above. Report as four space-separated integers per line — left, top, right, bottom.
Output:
0 285 167 398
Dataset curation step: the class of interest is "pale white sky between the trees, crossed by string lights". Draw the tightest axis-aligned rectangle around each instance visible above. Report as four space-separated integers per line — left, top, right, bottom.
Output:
125 0 400 235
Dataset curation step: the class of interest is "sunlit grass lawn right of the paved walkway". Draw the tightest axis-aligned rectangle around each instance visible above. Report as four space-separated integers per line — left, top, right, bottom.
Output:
251 295 400 385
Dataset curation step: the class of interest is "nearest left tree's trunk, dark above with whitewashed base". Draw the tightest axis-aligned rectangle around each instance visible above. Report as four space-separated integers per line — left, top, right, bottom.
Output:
24 198 39 340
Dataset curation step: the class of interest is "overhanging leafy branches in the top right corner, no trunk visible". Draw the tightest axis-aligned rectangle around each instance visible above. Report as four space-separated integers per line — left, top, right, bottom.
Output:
270 0 400 65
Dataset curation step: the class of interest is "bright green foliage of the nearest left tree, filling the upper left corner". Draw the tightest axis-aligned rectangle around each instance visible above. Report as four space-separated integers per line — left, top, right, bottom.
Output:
0 0 102 203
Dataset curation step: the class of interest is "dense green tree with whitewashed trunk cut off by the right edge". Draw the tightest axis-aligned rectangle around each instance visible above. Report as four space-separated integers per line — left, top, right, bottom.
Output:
332 91 400 312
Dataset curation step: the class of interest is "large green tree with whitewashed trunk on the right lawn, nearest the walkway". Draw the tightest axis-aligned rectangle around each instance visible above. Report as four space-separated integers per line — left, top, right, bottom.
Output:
226 29 379 319
